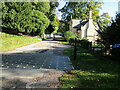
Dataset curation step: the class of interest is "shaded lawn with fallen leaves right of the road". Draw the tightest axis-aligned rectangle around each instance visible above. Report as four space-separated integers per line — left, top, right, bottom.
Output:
60 49 120 88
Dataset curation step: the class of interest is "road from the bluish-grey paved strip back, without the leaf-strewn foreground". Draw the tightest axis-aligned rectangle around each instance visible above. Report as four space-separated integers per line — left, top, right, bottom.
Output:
1 41 73 70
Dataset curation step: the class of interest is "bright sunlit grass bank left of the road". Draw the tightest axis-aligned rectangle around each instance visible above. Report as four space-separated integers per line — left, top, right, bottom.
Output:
0 33 40 52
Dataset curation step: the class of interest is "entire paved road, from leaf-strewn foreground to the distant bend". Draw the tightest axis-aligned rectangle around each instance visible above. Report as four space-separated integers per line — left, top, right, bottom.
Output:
0 40 74 88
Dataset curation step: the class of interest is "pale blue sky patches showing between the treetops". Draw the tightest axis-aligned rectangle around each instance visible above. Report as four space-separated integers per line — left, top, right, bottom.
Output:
56 0 119 19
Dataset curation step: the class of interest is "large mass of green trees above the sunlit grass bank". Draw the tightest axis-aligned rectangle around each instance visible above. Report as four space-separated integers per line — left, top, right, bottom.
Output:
2 2 58 36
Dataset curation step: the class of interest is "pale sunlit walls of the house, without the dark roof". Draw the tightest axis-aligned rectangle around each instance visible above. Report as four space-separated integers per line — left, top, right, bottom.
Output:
70 18 99 42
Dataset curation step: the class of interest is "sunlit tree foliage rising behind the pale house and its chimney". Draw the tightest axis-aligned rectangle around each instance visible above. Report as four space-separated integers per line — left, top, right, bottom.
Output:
60 0 102 21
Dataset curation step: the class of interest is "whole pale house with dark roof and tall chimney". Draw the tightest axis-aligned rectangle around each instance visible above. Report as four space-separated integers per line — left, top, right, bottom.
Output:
70 10 101 42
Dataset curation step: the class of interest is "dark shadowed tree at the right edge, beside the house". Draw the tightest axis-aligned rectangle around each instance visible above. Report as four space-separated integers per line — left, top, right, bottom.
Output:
98 14 120 53
